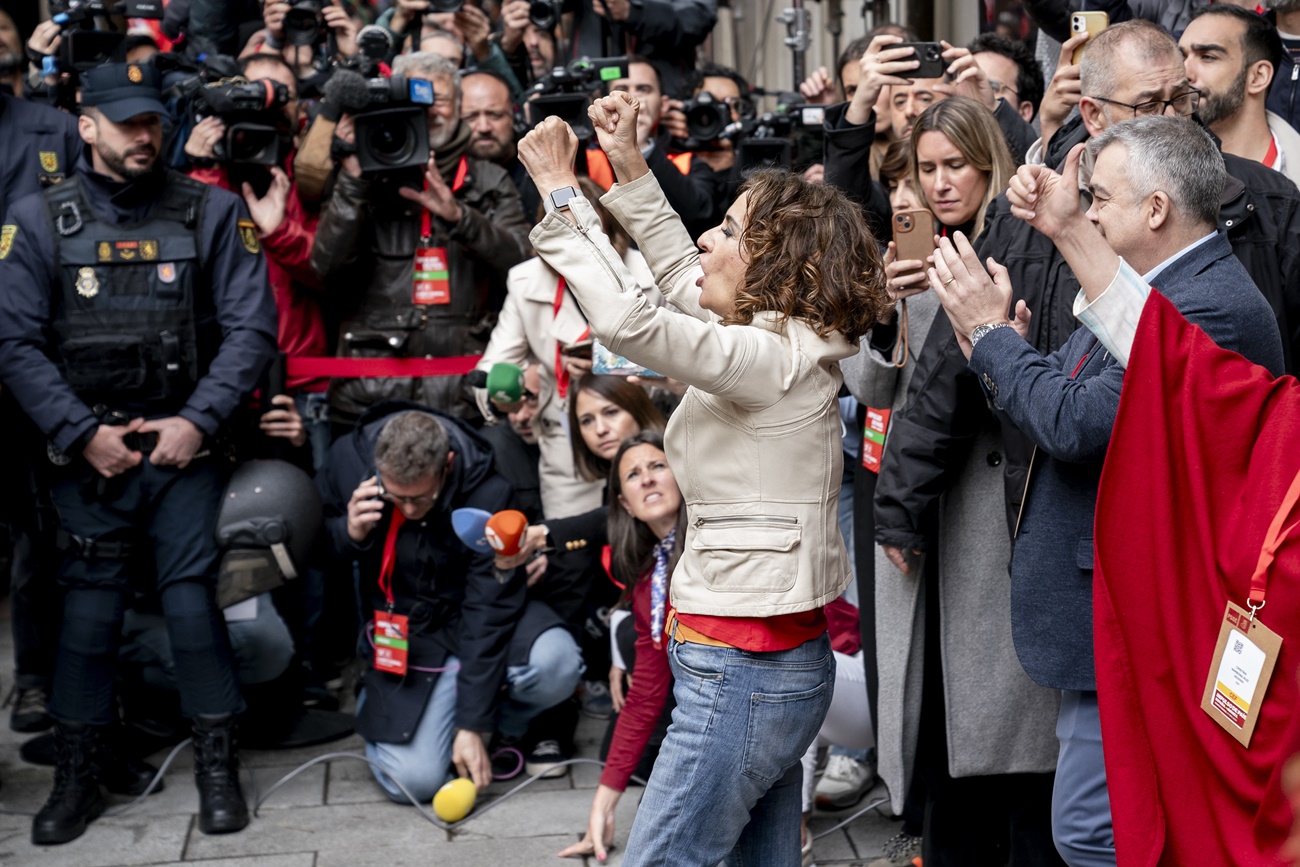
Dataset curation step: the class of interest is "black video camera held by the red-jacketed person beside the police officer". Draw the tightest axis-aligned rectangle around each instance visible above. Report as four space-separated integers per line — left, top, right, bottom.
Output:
194 79 293 166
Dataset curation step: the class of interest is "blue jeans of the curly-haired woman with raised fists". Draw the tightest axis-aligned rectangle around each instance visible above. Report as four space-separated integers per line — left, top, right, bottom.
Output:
623 634 835 867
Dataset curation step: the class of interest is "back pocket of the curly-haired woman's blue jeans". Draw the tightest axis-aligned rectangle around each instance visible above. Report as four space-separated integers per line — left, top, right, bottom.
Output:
741 682 831 785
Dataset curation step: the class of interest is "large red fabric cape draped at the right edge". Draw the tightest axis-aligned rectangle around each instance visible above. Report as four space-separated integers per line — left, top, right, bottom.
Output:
1093 292 1300 867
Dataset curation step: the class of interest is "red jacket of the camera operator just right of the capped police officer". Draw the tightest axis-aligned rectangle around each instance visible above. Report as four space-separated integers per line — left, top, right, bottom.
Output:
190 161 330 391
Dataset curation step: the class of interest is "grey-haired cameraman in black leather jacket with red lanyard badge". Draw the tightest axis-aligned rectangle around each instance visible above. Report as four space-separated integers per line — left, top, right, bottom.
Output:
311 52 530 429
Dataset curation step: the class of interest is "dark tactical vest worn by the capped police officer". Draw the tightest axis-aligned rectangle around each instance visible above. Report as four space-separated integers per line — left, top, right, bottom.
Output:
43 172 221 412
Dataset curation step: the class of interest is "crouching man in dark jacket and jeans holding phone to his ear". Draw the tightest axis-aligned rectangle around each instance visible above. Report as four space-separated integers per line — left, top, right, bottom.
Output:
317 402 582 803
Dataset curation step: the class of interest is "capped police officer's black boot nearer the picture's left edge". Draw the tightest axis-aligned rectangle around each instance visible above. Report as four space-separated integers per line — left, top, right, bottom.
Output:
31 723 104 846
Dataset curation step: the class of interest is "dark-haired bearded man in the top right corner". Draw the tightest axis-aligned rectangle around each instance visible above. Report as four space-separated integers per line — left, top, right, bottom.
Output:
1178 4 1300 183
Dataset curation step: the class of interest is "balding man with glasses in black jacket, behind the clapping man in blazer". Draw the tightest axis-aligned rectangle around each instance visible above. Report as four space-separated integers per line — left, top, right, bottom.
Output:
875 21 1300 562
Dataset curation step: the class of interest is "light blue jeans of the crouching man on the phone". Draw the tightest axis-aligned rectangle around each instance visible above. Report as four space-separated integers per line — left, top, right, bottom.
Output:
358 627 584 803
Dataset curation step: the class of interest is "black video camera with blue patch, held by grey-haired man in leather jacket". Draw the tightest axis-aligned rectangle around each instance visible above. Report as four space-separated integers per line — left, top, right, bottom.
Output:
354 75 433 172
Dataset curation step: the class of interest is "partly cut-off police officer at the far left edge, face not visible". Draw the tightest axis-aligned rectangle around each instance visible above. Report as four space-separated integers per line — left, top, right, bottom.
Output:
0 66 82 732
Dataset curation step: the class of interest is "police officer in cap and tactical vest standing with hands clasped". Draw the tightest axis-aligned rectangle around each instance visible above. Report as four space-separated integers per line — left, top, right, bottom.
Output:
0 64 276 844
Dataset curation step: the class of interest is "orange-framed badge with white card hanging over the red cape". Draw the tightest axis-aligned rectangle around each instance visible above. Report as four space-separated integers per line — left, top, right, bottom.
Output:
1201 602 1282 747
